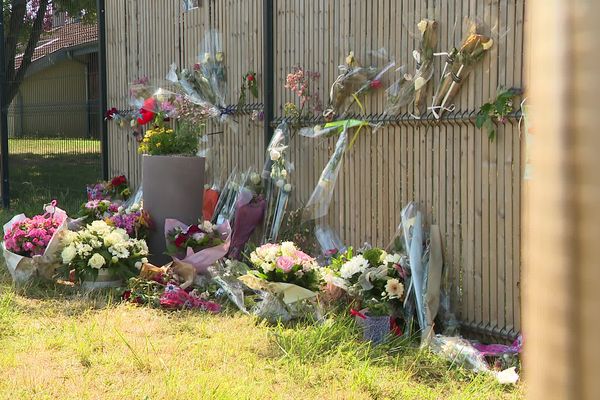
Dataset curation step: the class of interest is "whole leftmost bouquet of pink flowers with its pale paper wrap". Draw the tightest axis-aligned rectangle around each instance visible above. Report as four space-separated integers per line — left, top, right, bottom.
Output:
2 204 67 284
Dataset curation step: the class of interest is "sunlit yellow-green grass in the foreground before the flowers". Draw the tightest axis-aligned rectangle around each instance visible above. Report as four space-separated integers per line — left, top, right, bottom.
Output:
0 270 523 400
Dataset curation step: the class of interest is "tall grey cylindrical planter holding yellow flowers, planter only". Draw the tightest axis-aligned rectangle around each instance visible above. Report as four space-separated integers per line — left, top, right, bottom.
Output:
142 155 205 265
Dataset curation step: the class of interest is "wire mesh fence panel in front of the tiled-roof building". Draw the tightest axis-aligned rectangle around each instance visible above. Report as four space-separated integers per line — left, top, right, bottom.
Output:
5 7 103 216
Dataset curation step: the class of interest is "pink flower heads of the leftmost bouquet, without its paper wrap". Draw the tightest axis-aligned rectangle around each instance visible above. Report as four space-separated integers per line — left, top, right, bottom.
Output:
4 213 66 257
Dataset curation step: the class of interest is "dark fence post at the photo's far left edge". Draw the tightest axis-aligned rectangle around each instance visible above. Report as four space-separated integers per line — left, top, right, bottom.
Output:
0 0 10 209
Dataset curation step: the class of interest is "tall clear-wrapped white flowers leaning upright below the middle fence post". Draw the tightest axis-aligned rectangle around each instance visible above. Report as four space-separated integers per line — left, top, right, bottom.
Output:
262 122 293 243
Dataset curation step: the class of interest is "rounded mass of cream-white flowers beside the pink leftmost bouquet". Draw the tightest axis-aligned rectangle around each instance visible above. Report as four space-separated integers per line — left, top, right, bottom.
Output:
60 221 148 280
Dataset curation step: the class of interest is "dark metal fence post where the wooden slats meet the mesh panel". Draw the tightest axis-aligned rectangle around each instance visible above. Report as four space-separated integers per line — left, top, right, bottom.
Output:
96 0 108 179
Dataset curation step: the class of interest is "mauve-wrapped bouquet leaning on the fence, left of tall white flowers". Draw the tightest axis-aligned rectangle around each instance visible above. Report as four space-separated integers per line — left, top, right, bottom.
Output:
228 172 266 259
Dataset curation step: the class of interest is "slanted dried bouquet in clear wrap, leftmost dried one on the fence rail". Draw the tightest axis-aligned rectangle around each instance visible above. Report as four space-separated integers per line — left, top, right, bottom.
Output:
324 49 395 118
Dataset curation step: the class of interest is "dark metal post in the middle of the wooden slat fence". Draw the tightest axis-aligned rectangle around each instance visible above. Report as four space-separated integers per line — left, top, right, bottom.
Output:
263 0 275 149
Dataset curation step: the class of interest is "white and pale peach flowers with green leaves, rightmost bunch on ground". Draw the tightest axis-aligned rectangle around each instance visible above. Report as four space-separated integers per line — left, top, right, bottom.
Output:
325 248 407 315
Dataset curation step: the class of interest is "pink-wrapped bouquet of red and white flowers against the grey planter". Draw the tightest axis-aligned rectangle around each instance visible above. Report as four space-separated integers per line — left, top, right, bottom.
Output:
165 219 231 274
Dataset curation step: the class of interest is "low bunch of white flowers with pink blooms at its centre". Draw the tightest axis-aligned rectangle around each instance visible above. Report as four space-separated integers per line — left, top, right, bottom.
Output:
250 242 320 290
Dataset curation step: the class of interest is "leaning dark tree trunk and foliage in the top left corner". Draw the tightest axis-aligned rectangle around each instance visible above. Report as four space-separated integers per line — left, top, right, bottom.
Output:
0 0 96 104
